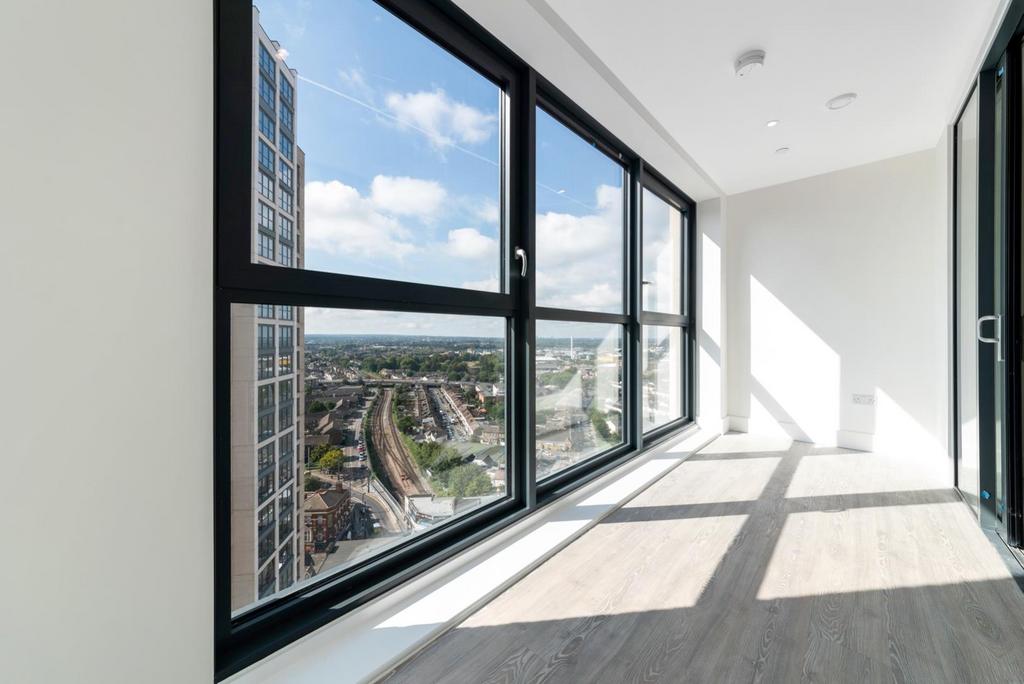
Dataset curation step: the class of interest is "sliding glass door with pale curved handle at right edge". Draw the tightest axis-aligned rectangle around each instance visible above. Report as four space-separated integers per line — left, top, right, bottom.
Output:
955 52 1020 541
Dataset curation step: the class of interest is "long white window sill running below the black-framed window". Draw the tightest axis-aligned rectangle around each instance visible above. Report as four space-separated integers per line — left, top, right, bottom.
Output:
224 425 720 684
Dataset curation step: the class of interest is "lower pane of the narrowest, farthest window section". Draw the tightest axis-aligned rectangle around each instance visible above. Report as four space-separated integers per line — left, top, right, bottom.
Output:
640 326 683 432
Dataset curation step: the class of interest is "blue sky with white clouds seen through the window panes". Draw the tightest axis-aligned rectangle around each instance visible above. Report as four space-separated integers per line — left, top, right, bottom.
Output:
257 0 623 334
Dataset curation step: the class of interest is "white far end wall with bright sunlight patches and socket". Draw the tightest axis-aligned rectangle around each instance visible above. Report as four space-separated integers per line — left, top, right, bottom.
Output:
726 143 949 467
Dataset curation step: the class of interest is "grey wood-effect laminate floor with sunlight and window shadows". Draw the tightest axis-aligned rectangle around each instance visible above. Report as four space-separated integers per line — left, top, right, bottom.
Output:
387 435 1024 683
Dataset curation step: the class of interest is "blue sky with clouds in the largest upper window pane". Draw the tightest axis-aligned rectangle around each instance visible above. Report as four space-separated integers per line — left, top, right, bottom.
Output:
254 0 505 292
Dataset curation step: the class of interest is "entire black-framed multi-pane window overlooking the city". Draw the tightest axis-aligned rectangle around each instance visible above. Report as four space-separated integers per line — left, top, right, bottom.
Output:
214 0 695 680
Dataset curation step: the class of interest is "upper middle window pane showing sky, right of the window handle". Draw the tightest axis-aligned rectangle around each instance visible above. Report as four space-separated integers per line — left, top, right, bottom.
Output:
534 109 626 313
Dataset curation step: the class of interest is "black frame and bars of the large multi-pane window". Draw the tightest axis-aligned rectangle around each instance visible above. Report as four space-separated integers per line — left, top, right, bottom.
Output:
213 0 697 681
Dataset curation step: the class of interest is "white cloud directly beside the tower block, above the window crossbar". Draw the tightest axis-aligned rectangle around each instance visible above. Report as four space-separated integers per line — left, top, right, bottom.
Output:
305 179 416 260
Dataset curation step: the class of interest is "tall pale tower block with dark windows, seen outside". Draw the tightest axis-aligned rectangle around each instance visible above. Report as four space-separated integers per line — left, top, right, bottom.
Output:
231 7 305 610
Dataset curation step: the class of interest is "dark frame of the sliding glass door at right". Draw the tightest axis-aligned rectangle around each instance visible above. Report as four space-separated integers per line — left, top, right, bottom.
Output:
950 26 1024 547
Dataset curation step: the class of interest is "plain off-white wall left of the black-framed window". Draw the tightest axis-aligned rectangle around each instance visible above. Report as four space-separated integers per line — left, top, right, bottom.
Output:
0 0 213 684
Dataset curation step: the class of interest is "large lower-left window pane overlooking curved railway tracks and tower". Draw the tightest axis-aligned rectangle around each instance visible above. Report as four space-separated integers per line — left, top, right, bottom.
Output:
230 304 505 614
